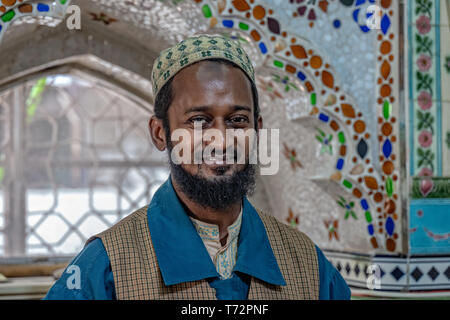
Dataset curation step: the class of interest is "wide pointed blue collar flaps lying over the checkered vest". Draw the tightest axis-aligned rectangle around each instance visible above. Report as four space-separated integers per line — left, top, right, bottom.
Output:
147 176 286 285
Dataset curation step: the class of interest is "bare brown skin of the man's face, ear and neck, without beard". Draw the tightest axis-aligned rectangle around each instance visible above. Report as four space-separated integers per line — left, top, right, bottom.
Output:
149 60 263 245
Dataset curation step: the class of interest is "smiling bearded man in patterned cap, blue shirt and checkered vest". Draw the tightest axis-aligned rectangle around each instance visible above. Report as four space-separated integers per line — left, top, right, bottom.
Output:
46 35 350 299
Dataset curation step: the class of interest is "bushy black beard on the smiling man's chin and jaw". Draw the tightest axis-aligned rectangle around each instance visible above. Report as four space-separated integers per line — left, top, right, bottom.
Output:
166 129 257 211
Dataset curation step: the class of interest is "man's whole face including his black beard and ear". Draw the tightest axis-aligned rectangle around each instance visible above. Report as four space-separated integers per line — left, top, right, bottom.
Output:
149 61 262 211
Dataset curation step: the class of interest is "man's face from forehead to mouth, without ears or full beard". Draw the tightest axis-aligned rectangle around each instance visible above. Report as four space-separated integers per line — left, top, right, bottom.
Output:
168 61 258 180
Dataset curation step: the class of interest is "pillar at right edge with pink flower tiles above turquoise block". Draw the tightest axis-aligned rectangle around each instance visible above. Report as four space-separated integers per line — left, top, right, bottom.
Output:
408 0 450 255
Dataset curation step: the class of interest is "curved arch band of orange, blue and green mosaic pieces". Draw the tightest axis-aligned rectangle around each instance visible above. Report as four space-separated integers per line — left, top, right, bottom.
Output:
196 0 390 249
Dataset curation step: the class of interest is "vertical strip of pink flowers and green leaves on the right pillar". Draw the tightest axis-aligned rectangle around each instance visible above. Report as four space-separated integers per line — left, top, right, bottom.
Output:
409 0 442 176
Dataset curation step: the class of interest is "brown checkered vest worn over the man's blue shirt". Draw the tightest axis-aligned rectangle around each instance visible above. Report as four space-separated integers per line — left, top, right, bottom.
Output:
88 206 319 300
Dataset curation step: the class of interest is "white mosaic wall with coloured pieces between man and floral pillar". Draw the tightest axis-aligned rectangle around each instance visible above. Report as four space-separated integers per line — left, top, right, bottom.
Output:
193 1 402 252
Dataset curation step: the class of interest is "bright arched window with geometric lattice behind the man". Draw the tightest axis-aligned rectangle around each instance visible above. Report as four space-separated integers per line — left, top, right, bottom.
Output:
0 75 168 256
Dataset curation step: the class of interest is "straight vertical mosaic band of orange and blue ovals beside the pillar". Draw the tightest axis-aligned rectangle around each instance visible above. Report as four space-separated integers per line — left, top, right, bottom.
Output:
376 1 401 252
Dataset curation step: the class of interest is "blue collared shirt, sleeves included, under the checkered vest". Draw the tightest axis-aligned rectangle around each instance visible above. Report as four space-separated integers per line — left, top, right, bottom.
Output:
44 177 350 300
